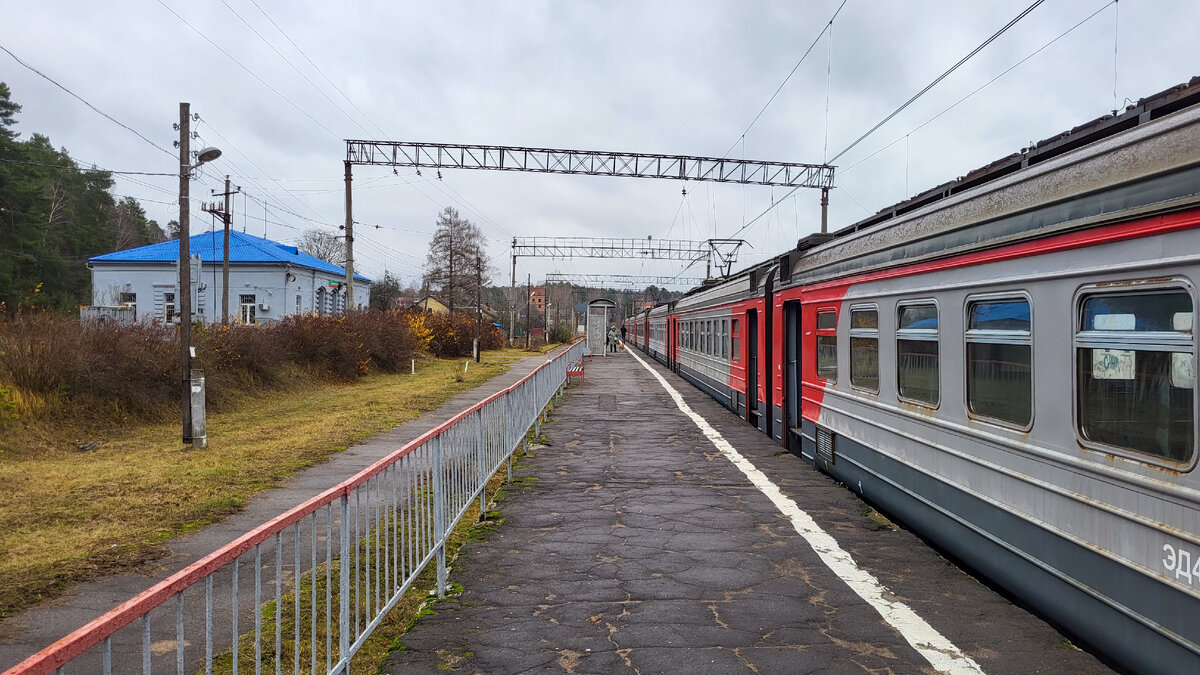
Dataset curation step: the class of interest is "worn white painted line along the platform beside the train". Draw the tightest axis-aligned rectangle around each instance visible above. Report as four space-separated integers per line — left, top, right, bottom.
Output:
628 350 983 674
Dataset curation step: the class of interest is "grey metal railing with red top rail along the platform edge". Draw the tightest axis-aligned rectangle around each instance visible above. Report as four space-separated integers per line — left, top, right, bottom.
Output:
7 341 583 675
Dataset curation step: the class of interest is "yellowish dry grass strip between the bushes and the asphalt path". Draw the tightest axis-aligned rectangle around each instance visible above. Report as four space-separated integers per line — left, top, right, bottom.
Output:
0 350 527 616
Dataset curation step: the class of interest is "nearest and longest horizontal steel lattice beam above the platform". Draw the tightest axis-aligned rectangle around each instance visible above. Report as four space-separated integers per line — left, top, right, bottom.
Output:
346 141 834 190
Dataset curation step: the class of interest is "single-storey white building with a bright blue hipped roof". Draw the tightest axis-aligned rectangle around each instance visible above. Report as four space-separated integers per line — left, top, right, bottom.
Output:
82 232 371 323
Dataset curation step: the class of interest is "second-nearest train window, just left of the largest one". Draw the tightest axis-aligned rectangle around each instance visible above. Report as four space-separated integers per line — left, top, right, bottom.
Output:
966 298 1033 428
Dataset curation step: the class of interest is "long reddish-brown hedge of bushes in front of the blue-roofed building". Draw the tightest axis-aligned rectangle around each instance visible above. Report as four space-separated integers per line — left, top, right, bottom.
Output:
0 310 427 418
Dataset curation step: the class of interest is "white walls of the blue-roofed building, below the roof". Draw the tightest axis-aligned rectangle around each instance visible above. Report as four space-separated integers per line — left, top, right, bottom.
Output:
91 262 371 323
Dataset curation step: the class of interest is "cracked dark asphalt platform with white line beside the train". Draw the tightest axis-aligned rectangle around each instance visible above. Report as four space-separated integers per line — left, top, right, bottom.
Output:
383 351 1109 674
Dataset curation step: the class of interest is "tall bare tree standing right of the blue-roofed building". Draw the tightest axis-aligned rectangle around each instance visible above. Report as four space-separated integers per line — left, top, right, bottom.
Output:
422 207 492 311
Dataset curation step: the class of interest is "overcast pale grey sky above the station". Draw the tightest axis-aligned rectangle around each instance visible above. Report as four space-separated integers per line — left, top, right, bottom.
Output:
0 0 1200 289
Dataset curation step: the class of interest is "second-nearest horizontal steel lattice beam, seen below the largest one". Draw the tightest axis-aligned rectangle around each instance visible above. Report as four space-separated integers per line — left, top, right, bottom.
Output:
512 237 712 262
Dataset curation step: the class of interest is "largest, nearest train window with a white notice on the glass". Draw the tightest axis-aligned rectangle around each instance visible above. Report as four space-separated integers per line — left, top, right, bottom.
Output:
1075 288 1195 461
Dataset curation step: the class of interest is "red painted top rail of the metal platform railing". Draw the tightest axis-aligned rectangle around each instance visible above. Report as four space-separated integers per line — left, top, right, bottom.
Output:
5 339 581 675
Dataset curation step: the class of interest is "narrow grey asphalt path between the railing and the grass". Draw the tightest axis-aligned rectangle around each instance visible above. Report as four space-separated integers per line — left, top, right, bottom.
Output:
0 354 559 673
